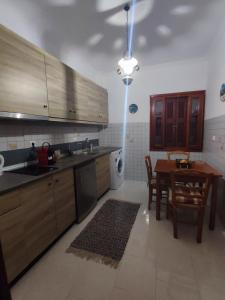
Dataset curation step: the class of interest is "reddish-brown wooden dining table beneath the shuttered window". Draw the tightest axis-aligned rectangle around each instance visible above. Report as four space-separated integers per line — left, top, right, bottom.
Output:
154 159 223 230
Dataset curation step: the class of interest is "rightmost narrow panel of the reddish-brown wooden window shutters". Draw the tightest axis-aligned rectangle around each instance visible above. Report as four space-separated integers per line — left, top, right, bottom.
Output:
189 93 205 150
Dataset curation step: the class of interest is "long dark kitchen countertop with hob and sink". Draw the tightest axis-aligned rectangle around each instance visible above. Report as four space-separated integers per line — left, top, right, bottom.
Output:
0 147 121 195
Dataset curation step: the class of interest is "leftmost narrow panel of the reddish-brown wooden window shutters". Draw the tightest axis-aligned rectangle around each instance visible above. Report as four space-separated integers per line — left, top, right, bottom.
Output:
150 96 165 150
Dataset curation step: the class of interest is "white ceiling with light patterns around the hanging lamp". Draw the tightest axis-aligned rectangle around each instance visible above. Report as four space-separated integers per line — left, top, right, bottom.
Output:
3 0 225 72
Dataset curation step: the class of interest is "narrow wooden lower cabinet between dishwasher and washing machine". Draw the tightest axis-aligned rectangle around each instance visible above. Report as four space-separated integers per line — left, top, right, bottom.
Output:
95 154 110 198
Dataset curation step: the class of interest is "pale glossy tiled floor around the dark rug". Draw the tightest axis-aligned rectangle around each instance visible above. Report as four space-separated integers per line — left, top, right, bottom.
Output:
12 181 225 300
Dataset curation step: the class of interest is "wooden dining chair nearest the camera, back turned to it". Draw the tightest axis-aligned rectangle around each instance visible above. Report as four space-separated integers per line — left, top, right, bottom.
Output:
167 170 211 243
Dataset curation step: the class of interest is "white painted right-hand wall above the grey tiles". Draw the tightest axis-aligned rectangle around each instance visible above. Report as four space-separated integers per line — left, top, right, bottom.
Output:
205 18 225 119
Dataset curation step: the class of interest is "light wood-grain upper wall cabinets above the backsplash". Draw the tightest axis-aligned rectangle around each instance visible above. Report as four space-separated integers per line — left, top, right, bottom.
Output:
0 25 108 124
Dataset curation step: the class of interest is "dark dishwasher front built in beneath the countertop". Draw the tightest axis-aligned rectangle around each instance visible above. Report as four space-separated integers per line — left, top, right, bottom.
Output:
74 160 97 223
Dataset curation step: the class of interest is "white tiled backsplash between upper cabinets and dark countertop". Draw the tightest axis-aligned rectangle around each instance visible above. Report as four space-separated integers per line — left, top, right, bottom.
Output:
0 120 99 151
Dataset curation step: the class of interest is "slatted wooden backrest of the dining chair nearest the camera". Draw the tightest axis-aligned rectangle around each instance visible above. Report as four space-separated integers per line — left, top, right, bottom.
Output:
171 170 211 206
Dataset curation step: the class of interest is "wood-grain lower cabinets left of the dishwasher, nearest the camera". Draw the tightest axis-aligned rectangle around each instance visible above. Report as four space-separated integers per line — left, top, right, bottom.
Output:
0 168 76 283
